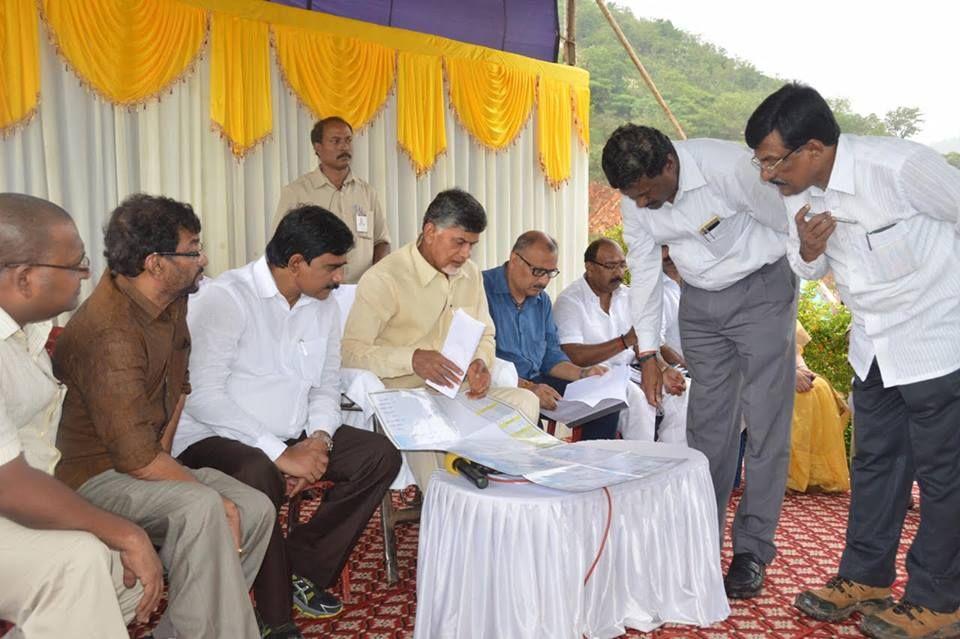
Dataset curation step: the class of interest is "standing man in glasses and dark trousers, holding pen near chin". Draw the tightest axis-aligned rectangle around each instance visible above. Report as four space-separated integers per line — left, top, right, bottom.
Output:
746 84 960 639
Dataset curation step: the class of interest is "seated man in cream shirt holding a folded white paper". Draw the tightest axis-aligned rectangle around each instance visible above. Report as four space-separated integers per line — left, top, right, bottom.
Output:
342 190 540 489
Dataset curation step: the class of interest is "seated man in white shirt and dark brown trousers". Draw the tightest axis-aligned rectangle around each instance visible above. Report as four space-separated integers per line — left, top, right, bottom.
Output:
173 205 400 638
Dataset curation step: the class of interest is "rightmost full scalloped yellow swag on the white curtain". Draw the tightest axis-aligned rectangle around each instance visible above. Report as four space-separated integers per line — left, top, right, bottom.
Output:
444 58 536 151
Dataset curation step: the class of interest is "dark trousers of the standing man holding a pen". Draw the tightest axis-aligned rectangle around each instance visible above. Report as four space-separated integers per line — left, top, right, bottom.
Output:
840 360 960 612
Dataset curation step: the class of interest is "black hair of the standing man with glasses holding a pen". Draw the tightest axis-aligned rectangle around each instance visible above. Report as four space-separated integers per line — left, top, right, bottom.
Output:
744 82 840 149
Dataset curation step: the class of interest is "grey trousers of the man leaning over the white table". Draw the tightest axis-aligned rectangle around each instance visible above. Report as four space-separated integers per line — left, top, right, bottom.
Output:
679 258 797 563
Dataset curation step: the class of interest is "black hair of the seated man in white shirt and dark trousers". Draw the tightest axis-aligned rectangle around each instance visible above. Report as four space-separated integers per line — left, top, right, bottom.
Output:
266 204 353 268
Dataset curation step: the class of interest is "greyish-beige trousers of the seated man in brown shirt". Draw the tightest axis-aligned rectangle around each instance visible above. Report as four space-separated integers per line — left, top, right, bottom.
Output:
78 468 276 639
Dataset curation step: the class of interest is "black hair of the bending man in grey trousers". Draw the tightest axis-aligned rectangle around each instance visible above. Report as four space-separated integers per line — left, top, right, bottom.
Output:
601 124 677 189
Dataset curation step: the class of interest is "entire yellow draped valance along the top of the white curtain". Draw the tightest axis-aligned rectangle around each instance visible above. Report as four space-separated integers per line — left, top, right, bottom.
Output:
0 0 590 186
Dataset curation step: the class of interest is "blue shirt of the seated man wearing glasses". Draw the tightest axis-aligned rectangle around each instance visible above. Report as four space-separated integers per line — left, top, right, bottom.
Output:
483 266 570 379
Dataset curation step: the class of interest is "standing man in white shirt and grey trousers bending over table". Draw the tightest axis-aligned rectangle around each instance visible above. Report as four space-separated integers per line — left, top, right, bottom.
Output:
602 124 797 598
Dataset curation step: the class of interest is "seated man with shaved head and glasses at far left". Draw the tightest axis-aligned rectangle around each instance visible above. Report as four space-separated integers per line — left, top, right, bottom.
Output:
0 193 163 639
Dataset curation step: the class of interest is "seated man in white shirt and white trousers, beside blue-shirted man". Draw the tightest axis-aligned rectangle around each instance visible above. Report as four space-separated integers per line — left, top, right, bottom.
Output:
553 238 687 444
